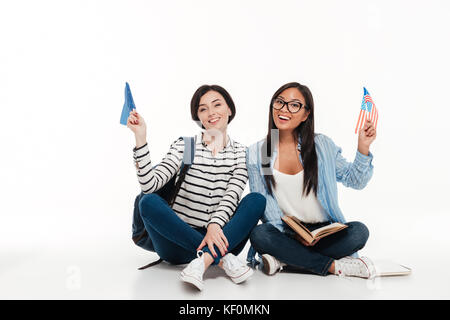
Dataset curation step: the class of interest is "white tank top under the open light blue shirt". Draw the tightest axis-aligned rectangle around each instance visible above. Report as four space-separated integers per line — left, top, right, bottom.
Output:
273 168 328 223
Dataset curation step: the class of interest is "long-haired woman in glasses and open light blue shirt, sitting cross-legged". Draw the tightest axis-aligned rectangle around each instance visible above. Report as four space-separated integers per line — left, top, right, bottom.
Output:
247 82 376 278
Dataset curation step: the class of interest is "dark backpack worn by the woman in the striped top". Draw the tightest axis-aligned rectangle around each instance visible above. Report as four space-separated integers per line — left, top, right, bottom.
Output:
132 137 196 270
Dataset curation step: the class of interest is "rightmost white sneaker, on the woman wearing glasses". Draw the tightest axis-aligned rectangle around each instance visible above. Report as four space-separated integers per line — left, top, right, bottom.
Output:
334 257 376 279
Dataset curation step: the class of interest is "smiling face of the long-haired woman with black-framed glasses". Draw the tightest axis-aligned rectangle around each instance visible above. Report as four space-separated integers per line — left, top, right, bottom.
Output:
272 88 309 131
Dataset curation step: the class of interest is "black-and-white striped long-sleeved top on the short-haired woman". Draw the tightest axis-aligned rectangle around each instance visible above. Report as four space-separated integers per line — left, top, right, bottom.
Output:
133 133 248 228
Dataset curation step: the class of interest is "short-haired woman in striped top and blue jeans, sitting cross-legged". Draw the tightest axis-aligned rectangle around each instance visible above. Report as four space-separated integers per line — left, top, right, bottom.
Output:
127 85 265 290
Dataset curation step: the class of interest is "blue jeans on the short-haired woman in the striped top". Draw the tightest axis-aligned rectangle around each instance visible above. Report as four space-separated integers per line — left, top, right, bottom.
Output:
133 193 266 264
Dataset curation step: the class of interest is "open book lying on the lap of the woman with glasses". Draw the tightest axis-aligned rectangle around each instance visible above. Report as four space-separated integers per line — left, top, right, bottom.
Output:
281 216 347 244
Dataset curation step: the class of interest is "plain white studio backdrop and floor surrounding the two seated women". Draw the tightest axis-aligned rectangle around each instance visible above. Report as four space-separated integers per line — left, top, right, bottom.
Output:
0 0 450 299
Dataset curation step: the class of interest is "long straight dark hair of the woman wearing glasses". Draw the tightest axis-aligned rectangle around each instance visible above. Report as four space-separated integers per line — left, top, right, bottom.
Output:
262 82 318 196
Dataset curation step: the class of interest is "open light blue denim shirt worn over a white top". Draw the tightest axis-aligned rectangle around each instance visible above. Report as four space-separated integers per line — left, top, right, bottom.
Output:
247 134 373 267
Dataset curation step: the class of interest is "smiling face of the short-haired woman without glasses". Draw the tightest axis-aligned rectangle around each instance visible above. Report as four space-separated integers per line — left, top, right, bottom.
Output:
197 90 231 131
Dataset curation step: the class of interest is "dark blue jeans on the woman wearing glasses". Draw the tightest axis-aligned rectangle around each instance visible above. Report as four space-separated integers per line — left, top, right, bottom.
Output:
250 222 369 276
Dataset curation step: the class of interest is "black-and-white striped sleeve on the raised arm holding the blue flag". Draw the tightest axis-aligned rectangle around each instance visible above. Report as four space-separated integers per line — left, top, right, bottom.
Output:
133 138 184 194
